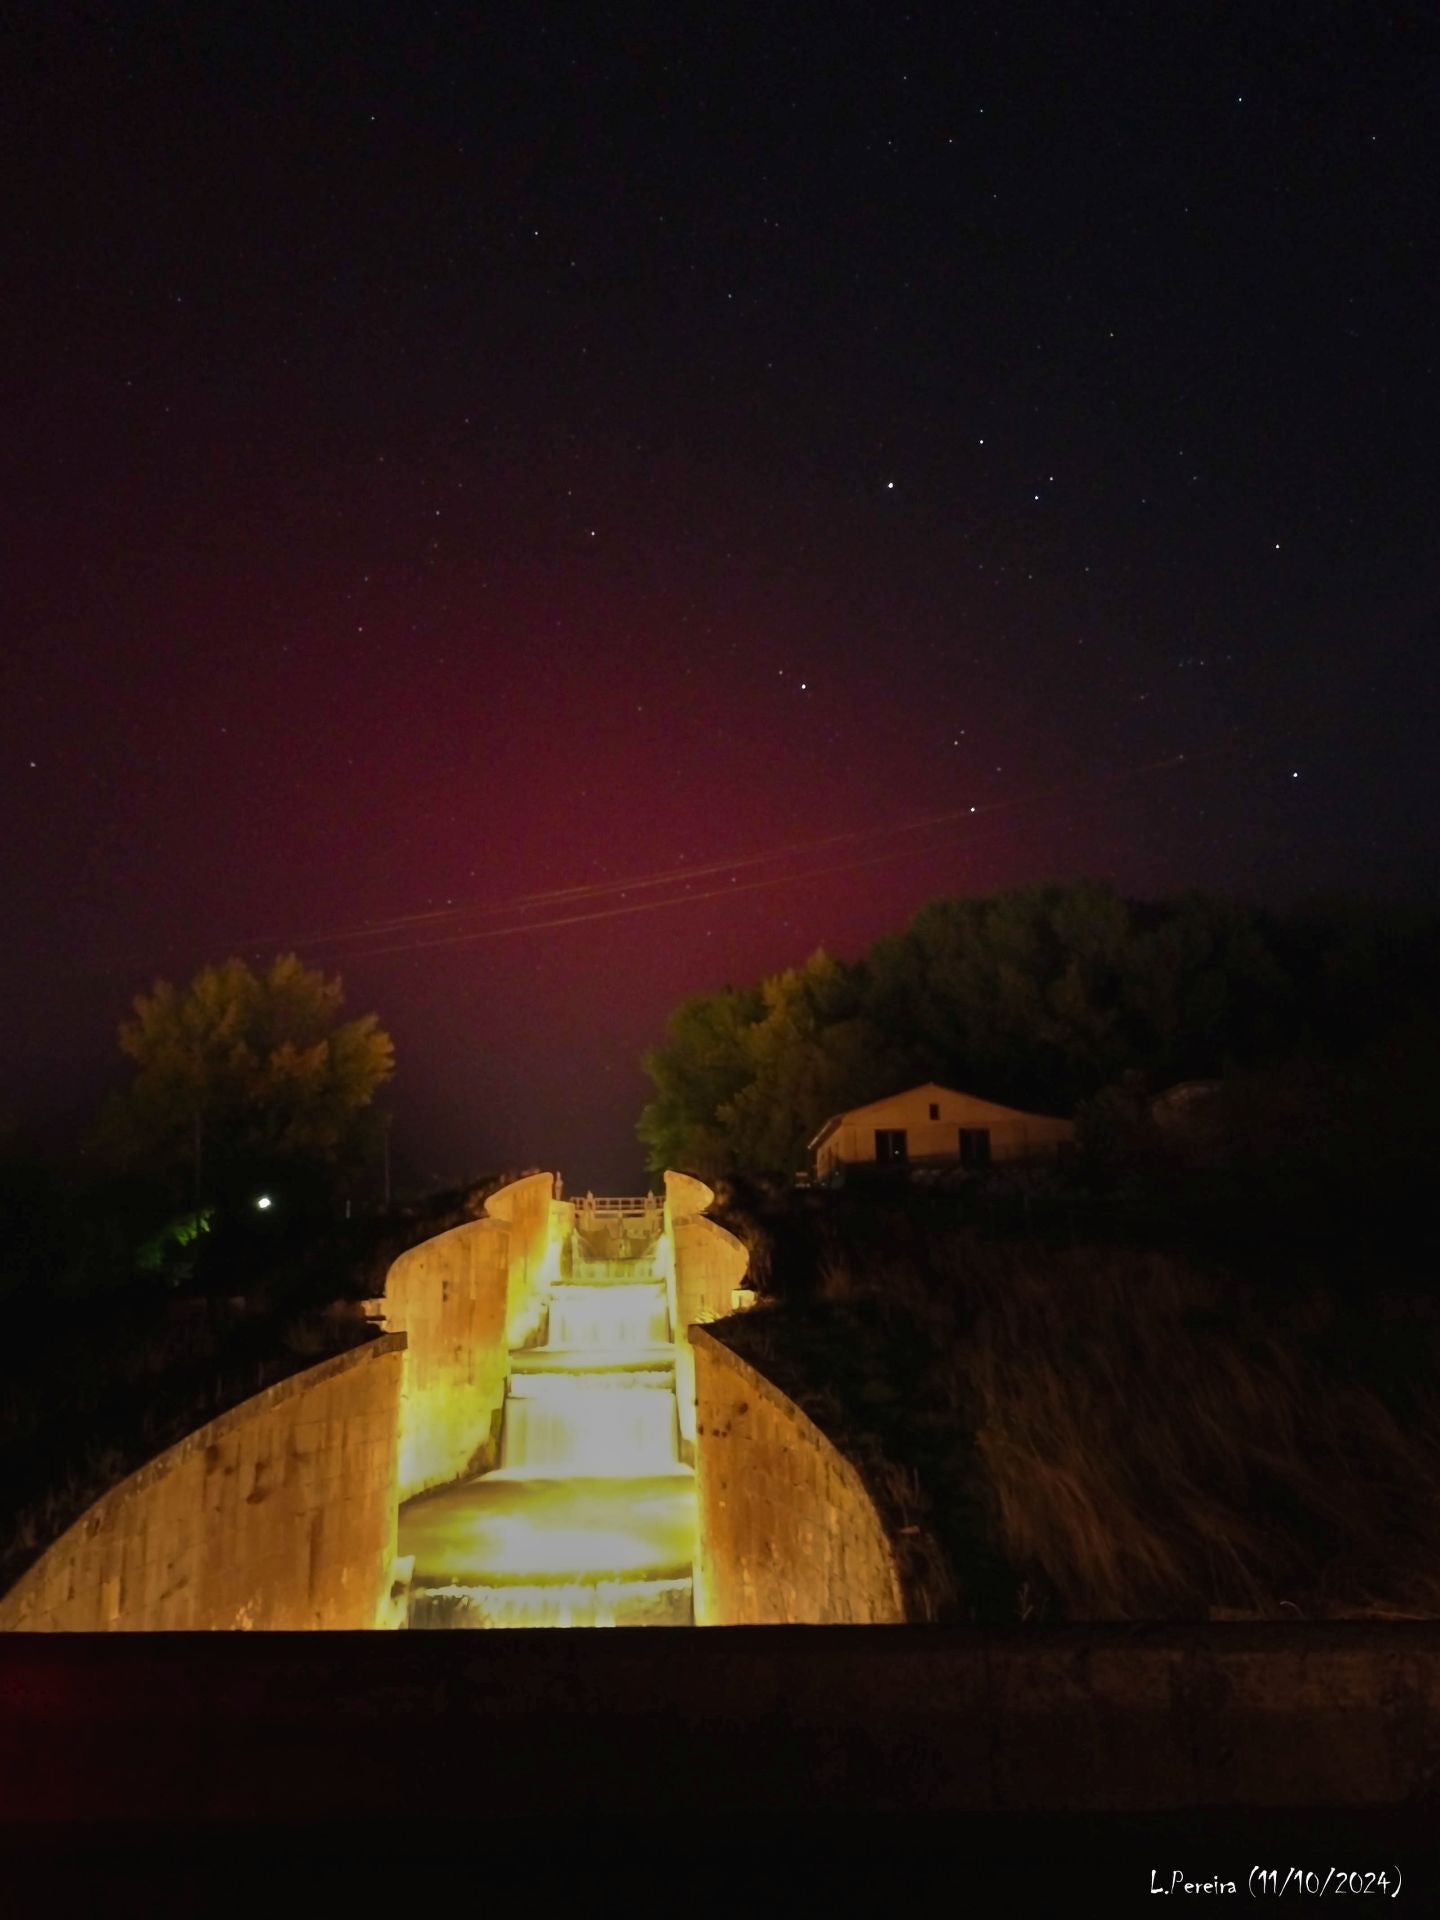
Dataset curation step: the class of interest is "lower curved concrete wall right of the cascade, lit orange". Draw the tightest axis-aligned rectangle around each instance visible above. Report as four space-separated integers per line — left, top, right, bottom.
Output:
689 1327 904 1626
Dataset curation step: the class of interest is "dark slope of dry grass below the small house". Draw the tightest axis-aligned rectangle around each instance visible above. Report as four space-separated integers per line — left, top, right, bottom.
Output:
733 1235 1440 1620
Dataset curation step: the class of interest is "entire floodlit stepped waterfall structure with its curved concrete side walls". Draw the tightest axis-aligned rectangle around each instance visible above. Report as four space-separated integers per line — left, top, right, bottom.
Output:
0 1173 902 1632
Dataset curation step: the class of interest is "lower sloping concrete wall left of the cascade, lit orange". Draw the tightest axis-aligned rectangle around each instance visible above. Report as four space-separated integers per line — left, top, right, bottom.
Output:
0 1334 405 1632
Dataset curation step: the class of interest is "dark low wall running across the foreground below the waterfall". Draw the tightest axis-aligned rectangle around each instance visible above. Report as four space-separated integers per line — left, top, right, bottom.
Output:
14 1620 1440 1820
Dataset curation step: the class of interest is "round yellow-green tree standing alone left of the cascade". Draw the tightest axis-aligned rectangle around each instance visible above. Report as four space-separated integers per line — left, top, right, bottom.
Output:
102 954 396 1204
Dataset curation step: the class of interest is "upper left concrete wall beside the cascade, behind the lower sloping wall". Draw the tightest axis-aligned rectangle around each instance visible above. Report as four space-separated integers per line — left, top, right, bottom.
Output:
384 1173 564 1500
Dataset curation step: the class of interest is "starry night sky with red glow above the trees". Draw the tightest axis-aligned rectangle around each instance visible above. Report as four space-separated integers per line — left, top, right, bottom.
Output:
0 0 1440 1190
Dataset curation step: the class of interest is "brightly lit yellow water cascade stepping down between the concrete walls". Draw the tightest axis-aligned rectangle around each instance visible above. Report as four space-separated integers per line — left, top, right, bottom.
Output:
399 1196 695 1626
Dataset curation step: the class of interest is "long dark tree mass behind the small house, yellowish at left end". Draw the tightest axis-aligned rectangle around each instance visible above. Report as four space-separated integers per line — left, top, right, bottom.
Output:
639 883 1436 1173
